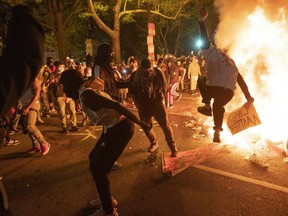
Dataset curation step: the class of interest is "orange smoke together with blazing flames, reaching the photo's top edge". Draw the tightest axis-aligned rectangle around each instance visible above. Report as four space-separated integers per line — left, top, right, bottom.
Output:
208 0 288 141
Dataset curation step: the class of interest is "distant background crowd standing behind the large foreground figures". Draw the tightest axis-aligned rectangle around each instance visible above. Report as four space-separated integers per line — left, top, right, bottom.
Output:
3 52 205 150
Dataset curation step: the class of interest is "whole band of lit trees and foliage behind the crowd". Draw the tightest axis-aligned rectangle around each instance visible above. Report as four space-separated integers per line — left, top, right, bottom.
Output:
7 0 217 62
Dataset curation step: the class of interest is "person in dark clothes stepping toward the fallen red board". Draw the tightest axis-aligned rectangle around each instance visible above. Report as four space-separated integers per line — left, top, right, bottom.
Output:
129 59 178 157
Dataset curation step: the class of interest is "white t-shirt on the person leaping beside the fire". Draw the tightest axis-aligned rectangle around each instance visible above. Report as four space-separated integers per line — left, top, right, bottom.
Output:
201 44 238 91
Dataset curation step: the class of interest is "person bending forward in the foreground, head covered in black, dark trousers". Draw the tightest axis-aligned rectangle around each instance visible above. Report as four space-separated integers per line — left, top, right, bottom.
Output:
60 70 150 216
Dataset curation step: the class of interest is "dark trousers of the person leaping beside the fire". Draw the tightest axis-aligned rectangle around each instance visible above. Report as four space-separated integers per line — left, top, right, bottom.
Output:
197 77 234 131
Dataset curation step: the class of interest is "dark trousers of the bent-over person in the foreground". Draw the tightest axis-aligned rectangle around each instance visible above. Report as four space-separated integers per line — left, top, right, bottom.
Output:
89 119 135 214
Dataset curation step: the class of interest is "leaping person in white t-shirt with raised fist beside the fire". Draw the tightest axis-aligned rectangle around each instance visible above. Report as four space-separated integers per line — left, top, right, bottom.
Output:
198 8 254 143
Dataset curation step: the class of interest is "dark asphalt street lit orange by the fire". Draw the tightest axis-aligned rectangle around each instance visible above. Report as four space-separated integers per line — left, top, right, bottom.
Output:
0 95 288 216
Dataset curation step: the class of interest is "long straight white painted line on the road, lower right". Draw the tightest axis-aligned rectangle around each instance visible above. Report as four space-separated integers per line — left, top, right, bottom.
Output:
192 165 288 193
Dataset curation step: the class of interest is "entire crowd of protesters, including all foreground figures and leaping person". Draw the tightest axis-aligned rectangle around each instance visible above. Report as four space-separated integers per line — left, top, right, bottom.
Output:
0 6 254 216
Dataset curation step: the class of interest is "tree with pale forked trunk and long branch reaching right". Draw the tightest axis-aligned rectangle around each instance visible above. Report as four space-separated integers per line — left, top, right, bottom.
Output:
87 0 196 63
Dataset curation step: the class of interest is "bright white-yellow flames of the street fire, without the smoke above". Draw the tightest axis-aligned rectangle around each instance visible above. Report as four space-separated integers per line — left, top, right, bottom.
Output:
209 6 288 156
